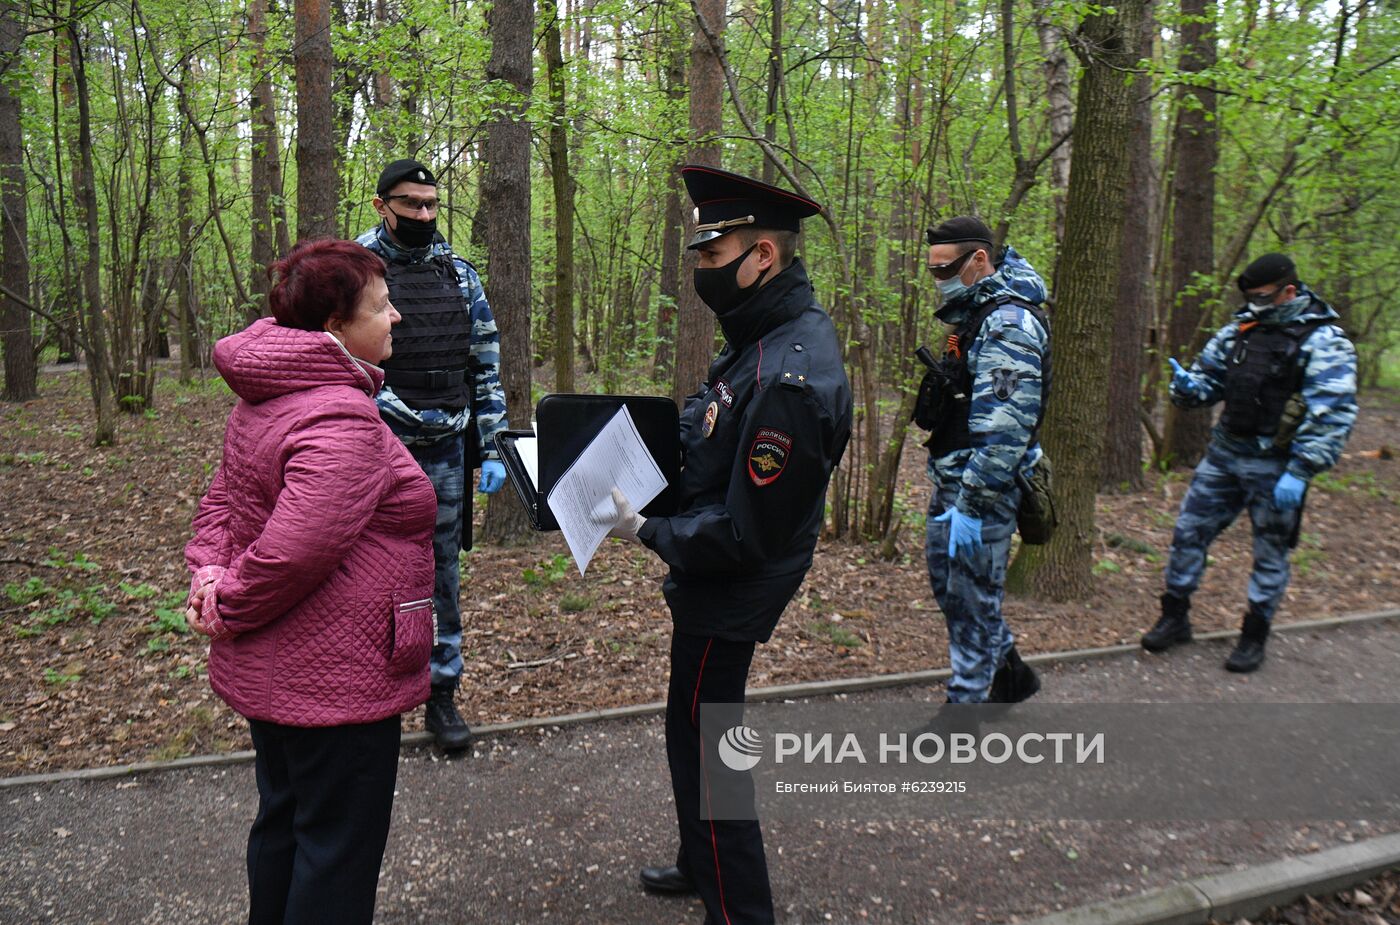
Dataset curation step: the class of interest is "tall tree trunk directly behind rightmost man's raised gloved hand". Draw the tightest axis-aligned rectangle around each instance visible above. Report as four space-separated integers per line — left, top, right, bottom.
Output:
1159 0 1219 466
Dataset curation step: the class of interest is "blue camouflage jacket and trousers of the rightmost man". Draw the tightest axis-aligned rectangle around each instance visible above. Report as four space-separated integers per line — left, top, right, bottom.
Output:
1166 284 1357 620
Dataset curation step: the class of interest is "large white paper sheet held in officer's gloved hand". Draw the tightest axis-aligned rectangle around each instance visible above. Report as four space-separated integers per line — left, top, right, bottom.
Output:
546 404 666 575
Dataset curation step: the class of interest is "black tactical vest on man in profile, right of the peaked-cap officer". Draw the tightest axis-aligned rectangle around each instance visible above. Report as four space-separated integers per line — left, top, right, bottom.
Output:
914 295 1050 458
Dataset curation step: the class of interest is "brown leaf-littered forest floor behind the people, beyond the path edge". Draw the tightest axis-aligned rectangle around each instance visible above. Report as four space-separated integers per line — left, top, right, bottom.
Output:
0 371 1400 775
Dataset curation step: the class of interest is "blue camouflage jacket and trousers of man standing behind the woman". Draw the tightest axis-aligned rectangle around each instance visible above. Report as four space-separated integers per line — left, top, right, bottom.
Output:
356 223 508 687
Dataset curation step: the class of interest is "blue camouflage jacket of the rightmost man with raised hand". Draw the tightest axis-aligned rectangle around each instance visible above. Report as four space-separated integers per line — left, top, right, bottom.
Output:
1169 285 1357 480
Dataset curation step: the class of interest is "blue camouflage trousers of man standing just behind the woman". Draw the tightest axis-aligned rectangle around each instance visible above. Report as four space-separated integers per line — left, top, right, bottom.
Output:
409 434 466 690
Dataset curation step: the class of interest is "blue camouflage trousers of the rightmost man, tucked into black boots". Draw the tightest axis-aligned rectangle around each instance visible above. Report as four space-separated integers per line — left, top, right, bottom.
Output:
1166 442 1302 620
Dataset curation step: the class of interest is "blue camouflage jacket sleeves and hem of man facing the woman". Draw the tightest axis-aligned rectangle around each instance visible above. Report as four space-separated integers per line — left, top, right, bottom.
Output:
356 223 510 459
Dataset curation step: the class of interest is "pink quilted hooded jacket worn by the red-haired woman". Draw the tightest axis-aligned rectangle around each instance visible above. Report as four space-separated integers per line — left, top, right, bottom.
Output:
185 318 437 726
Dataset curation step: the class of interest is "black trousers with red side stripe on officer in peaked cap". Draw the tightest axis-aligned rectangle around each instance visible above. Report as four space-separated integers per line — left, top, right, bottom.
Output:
666 633 773 925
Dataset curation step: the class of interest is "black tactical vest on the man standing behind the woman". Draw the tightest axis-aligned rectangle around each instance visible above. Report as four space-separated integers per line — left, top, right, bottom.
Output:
384 256 472 411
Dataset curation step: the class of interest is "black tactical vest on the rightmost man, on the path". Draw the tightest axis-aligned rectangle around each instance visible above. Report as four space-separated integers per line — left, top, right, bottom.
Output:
1221 318 1330 437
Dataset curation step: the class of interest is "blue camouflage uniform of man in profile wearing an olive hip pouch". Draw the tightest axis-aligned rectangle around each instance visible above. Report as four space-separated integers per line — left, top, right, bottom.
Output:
925 248 1049 702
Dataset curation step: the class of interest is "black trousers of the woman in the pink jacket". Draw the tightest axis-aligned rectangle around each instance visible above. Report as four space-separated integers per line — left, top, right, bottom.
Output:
248 716 400 925
